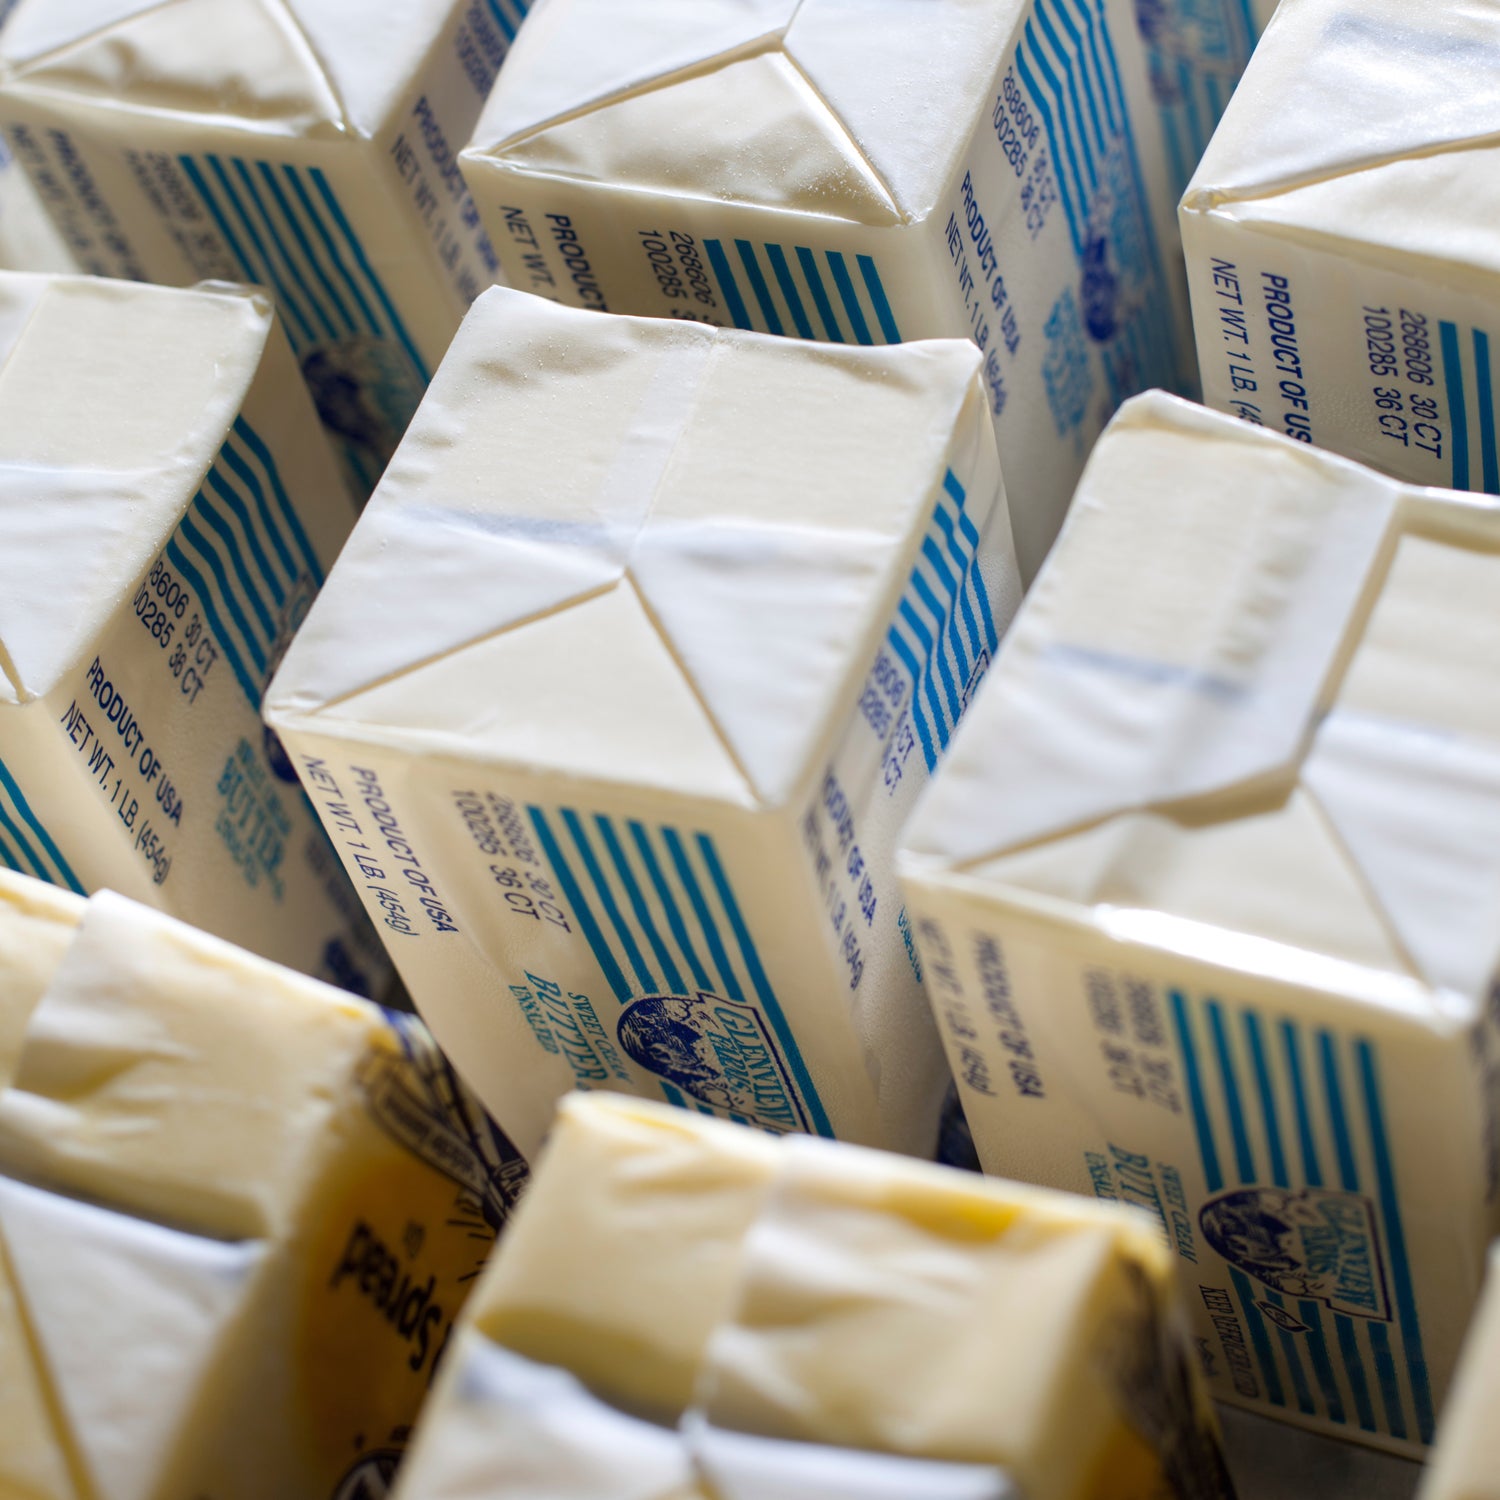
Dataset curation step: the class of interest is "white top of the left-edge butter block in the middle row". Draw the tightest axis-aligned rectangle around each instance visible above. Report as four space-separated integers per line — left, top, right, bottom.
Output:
0 273 273 704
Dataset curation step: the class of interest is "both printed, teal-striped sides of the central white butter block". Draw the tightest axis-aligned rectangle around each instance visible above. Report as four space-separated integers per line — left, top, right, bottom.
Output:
271 395 1019 1155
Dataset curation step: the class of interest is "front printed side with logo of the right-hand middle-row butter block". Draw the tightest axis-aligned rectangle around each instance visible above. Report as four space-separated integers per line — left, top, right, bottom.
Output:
908 881 1497 1455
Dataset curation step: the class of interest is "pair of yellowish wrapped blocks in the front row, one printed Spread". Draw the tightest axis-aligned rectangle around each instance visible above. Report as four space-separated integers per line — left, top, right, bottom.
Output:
0 875 1230 1500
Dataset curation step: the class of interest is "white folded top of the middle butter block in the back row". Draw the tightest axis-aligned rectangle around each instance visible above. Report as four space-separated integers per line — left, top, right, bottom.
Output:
470 0 1026 225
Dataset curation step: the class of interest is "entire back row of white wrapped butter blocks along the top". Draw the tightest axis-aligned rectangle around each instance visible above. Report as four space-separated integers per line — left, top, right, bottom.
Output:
0 0 1482 578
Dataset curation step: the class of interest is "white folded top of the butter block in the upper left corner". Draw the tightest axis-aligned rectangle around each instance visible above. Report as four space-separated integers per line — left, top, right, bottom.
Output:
0 0 477 135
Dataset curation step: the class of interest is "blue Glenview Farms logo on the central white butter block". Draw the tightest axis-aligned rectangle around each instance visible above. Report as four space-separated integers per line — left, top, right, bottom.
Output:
618 990 809 1131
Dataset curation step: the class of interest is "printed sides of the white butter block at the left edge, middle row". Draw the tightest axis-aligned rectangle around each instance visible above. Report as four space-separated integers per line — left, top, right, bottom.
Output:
0 282 386 993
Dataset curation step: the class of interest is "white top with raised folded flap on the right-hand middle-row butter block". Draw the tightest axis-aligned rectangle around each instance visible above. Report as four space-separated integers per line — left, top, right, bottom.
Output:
903 393 1500 1016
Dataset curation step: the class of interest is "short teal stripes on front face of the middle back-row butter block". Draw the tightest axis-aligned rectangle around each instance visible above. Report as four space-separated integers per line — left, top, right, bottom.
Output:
704 240 902 344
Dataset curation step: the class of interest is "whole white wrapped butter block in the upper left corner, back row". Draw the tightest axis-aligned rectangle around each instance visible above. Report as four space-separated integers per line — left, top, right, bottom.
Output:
0 0 528 495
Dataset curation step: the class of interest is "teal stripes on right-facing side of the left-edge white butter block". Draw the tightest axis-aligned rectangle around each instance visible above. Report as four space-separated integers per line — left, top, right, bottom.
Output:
167 417 323 714
